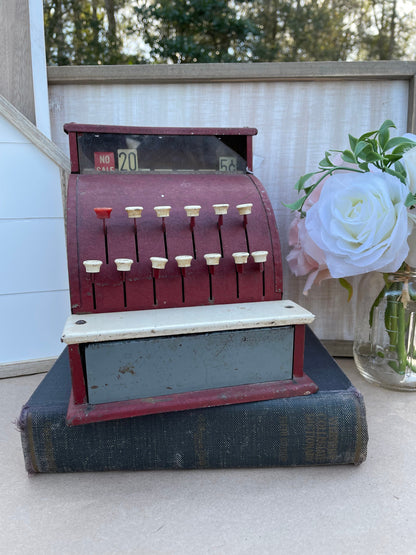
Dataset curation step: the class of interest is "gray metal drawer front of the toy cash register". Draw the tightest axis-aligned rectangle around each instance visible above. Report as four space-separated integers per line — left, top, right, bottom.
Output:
85 326 294 404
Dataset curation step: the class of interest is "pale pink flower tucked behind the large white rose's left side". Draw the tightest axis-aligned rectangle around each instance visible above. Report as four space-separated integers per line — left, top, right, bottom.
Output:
286 180 331 295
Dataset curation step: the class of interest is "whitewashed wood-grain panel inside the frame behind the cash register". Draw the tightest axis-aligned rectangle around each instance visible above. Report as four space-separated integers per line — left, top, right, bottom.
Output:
49 75 409 340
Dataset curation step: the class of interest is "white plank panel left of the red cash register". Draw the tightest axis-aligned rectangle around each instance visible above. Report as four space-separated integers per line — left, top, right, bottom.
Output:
0 111 70 370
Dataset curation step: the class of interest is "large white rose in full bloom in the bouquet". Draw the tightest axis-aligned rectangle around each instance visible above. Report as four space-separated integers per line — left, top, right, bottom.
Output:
305 172 412 278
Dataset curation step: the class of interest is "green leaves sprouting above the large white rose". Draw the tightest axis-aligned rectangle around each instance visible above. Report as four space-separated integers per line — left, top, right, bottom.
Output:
285 120 416 216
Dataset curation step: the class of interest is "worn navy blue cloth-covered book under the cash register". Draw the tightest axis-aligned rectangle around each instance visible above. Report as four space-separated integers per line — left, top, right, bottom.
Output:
19 329 368 473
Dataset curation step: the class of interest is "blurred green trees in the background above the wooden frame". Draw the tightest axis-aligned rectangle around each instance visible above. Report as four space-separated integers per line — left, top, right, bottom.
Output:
44 0 416 65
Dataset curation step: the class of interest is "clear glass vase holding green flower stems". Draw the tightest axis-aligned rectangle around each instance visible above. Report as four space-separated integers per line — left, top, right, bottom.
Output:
354 266 416 391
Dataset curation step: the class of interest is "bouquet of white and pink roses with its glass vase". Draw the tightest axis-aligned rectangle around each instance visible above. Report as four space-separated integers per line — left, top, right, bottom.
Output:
286 120 416 390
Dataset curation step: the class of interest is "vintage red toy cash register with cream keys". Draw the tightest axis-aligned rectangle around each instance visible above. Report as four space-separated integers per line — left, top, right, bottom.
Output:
62 123 317 425
